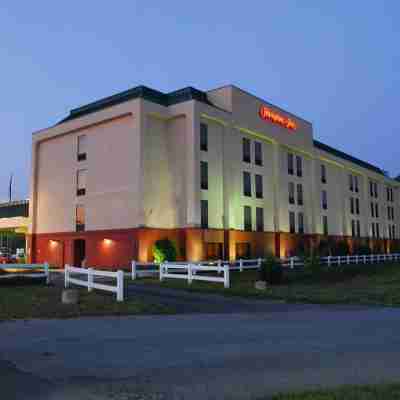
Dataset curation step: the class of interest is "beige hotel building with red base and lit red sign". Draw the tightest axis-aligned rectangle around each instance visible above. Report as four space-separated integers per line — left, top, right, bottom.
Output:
28 86 400 268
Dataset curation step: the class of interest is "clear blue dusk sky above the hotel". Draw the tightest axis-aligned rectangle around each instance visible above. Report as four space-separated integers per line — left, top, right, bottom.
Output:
0 0 400 200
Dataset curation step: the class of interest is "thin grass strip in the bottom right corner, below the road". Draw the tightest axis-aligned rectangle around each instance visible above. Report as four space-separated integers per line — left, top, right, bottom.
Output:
270 384 400 400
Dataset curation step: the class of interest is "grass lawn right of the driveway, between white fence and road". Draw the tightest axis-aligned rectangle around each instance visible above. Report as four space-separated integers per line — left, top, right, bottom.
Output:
143 263 400 306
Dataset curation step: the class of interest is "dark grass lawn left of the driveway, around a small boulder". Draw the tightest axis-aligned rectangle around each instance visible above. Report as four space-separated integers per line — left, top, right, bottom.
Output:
0 282 174 321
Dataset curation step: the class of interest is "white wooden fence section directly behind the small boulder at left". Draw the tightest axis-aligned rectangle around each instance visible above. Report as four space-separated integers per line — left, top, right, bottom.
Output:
64 265 124 301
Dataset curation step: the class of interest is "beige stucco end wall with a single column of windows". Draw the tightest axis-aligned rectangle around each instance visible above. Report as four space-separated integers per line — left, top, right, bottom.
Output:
31 102 140 233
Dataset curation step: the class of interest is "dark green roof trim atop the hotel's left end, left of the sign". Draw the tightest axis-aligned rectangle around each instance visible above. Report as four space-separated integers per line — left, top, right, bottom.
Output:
59 86 213 124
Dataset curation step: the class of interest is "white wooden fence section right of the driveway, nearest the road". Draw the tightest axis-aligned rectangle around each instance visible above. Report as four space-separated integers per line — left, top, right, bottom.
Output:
160 263 230 288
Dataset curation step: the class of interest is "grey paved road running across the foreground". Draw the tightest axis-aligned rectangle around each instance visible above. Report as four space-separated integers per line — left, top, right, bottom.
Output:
0 300 400 400
